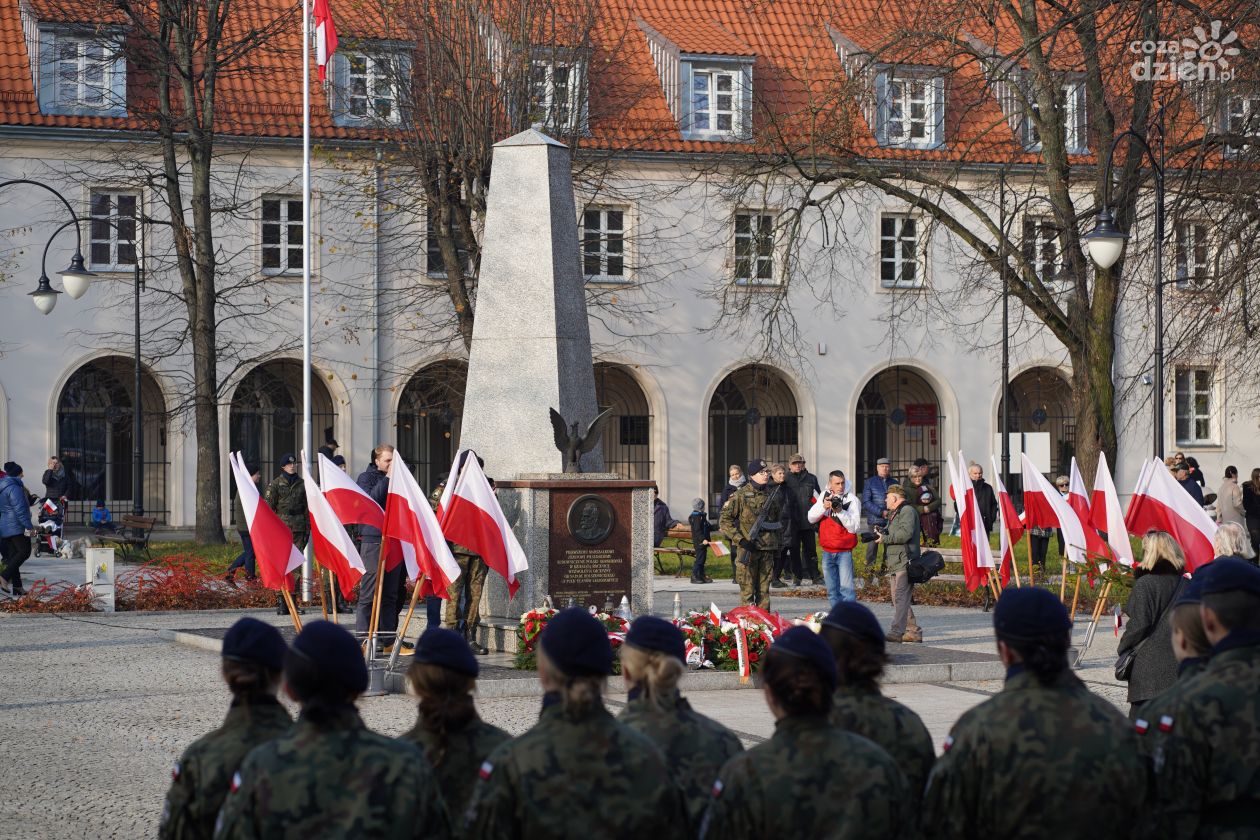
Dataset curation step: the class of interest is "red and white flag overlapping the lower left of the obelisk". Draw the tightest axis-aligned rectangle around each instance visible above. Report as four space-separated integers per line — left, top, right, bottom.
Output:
438 453 529 597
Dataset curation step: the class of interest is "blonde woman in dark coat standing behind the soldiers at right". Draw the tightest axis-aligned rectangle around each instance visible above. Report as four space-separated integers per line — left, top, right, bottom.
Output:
1116 531 1186 718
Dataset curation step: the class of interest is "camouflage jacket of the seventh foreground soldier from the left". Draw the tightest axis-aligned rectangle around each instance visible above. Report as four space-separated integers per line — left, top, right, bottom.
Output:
832 686 936 809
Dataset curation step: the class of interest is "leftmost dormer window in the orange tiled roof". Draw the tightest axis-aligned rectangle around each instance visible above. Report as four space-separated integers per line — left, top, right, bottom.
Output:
38 25 127 117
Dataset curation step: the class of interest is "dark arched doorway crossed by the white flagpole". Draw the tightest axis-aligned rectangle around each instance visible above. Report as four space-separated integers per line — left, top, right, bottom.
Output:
228 359 336 483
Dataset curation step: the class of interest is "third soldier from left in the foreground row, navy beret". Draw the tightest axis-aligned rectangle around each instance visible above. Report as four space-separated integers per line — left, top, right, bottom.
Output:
401 627 512 820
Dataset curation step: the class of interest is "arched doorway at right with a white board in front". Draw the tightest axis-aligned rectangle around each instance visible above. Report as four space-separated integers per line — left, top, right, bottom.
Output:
993 368 1076 487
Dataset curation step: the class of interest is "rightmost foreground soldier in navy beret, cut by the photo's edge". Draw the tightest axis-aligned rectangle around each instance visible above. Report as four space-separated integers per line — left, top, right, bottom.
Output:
1139 558 1260 837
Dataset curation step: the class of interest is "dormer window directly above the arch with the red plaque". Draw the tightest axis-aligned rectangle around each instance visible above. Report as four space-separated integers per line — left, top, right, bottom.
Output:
876 67 945 149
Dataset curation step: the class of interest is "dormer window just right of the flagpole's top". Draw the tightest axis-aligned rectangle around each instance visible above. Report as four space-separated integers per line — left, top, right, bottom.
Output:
333 44 411 126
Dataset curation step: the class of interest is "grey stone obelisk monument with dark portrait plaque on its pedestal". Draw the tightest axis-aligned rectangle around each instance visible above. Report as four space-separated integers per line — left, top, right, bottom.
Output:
460 130 653 650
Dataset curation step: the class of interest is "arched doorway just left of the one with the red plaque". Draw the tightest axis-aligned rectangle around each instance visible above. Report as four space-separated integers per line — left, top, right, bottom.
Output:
708 365 800 504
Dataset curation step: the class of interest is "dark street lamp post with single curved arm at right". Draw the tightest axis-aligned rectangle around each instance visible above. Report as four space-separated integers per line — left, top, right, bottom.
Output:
1084 108 1167 458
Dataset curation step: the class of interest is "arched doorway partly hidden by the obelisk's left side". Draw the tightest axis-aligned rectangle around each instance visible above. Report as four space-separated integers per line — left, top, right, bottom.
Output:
394 360 469 491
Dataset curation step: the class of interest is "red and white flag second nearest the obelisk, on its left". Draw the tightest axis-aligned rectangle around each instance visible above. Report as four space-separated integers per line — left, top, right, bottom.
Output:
381 452 460 598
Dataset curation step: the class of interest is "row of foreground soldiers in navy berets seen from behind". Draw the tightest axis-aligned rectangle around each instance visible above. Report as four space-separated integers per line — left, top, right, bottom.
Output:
160 549 1260 839
